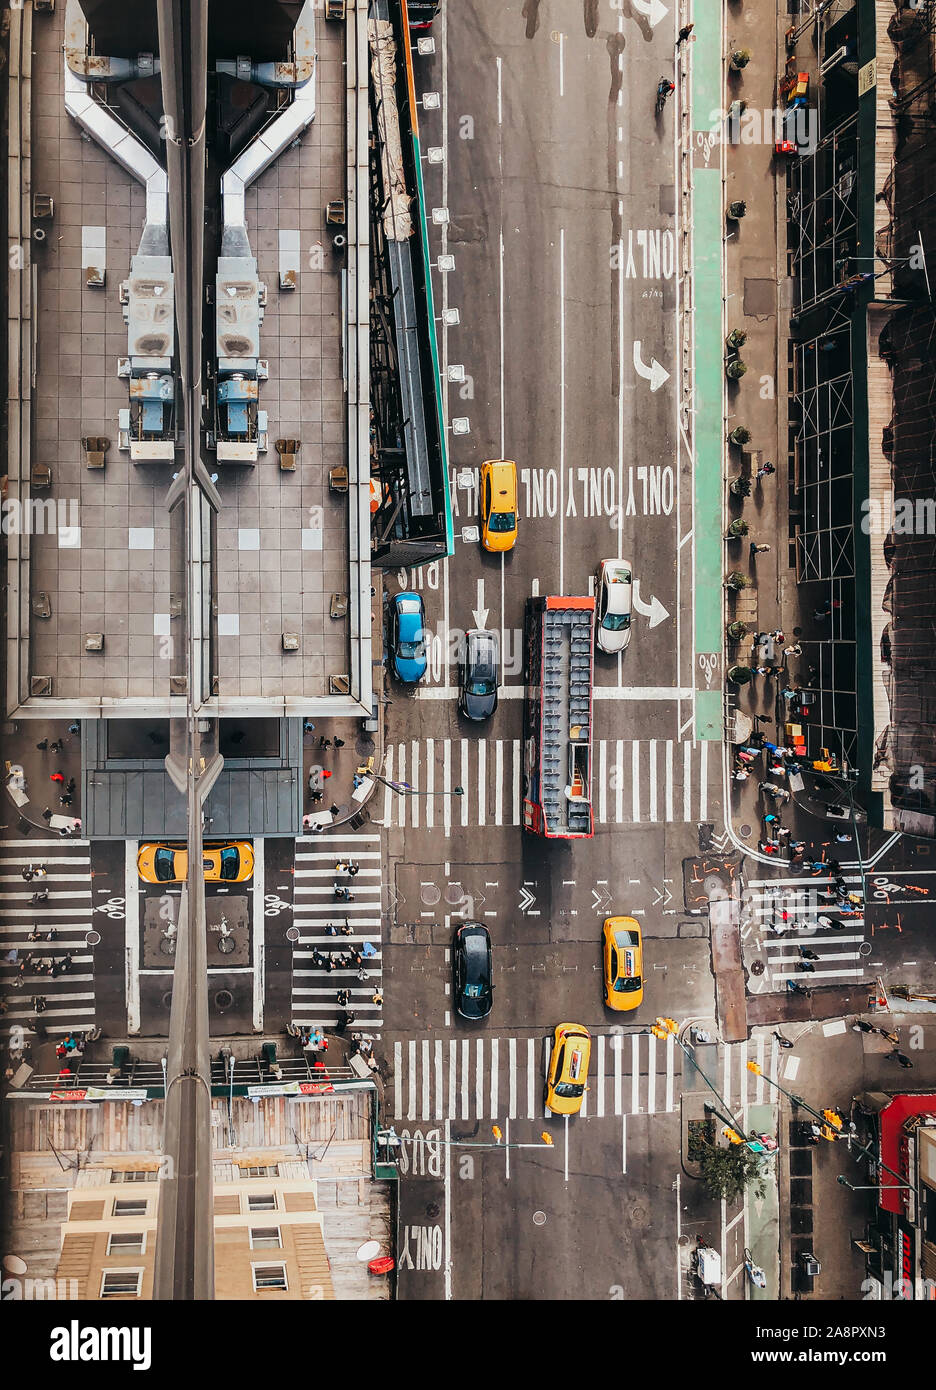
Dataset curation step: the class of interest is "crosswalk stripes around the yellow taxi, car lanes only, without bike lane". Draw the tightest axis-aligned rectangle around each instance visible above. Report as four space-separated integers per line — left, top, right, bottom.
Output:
392 1033 681 1120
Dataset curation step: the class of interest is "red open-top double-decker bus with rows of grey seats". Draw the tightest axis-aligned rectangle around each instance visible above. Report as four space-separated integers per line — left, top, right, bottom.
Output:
523 595 595 840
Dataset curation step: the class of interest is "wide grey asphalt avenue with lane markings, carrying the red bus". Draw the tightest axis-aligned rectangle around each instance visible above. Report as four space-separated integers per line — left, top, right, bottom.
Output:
371 3 723 1300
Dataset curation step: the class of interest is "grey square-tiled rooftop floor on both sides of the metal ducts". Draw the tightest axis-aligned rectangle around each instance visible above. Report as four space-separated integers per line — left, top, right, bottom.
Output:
31 5 354 698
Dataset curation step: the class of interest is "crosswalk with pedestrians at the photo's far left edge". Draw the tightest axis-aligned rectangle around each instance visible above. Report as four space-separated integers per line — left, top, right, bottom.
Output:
0 838 95 1037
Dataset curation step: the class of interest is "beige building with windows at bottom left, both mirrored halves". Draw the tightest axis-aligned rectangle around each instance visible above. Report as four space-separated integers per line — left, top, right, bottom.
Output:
3 1091 389 1300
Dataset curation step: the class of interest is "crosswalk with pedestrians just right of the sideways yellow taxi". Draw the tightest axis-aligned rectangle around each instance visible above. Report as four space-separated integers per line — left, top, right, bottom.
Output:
292 834 382 1031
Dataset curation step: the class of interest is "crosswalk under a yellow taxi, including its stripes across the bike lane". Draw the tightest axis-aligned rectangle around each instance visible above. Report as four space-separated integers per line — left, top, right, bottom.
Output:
392 1033 783 1122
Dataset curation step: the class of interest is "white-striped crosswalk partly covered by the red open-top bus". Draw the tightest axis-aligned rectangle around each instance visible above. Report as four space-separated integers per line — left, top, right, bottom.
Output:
382 738 720 835
